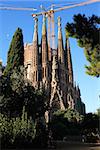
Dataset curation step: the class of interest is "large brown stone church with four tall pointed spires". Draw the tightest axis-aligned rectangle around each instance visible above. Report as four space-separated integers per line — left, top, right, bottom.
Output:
24 15 85 114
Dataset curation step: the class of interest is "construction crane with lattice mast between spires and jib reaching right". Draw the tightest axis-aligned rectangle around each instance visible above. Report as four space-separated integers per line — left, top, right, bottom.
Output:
32 0 100 50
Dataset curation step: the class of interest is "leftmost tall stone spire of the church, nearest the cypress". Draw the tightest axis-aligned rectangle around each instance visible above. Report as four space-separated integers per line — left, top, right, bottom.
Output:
32 18 39 88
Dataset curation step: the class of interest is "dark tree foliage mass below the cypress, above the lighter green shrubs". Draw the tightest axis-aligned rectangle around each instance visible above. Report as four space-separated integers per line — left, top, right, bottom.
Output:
0 67 46 119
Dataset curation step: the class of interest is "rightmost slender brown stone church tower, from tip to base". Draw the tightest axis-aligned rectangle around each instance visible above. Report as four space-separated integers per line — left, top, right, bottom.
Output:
65 34 75 109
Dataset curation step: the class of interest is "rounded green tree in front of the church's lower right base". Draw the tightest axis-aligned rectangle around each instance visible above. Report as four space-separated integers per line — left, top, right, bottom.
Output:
51 109 83 140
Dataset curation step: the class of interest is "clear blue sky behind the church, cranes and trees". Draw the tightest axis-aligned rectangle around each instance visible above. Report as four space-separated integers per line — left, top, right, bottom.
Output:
0 0 100 112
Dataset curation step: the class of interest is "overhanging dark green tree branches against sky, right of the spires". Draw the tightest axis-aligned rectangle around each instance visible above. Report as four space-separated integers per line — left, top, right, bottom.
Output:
66 14 100 77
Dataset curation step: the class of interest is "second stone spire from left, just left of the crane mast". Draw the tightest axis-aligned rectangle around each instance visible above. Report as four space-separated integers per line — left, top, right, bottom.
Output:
42 15 49 88
